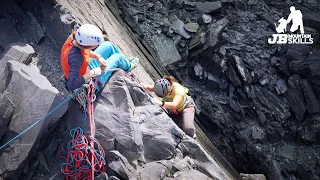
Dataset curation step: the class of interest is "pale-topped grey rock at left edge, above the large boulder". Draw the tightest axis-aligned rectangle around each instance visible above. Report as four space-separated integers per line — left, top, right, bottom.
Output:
0 43 35 65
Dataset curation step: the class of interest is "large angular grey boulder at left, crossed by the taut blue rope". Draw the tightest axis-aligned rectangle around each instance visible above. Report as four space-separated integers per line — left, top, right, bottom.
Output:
0 61 68 179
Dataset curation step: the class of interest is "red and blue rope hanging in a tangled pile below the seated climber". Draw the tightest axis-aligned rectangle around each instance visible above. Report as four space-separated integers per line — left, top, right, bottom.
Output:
59 79 105 180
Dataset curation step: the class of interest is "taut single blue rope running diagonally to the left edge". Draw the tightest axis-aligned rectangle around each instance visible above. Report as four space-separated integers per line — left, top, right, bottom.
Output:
0 86 84 151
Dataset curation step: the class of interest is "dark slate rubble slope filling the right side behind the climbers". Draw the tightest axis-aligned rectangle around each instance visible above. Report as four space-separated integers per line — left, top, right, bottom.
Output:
117 0 320 179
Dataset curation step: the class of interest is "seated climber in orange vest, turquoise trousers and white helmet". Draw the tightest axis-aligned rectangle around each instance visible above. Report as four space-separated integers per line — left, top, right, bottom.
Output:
61 24 139 91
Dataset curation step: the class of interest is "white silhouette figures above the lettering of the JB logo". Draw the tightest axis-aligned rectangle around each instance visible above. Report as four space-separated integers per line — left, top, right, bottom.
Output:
275 6 304 34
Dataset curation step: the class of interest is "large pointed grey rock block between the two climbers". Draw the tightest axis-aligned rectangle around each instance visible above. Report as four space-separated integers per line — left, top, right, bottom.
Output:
67 70 182 163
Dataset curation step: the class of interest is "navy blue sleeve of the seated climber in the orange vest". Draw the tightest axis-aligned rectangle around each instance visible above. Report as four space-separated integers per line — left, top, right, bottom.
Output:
67 53 85 91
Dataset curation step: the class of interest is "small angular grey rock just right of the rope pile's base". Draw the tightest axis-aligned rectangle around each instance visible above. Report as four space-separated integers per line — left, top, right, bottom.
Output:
109 151 137 179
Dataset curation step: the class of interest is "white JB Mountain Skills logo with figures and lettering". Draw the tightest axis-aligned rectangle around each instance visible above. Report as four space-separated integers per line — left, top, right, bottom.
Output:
268 6 313 44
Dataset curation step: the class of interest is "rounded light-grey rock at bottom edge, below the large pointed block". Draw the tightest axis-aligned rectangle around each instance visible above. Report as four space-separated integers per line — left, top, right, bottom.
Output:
140 162 170 180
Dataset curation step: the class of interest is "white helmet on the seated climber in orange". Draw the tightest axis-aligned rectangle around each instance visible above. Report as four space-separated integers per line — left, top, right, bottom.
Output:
76 24 104 46
